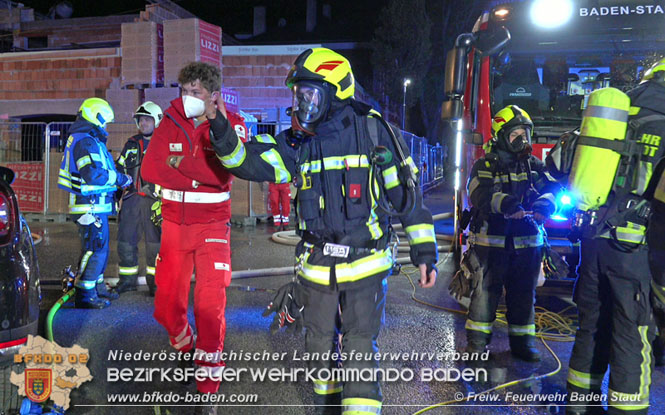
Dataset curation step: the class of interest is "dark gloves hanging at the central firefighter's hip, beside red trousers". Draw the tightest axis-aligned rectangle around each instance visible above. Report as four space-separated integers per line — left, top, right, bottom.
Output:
263 282 305 334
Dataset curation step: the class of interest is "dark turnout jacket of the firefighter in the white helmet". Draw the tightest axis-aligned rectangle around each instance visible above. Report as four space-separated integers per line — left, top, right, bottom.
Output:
116 134 158 199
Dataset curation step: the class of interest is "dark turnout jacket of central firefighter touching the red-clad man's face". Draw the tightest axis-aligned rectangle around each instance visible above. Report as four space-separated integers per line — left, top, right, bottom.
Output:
212 102 437 289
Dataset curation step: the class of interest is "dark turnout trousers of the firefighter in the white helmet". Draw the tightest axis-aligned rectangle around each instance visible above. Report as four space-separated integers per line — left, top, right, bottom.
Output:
118 194 162 292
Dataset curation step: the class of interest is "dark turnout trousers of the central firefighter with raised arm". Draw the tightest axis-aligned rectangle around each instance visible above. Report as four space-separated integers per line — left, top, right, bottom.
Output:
303 279 388 414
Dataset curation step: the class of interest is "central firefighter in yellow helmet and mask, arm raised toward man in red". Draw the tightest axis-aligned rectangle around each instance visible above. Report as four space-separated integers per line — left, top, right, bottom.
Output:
211 48 437 414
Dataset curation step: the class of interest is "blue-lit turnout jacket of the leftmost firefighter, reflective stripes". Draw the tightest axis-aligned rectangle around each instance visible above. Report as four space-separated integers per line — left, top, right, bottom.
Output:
58 118 123 214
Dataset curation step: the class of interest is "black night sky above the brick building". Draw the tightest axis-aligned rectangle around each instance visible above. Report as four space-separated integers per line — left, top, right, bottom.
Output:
23 0 387 41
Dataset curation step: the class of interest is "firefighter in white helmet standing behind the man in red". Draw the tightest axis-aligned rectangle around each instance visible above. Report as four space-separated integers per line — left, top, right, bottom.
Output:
116 101 164 296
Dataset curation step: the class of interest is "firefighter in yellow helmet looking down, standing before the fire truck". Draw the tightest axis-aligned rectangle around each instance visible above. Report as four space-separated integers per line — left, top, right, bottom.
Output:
465 105 561 362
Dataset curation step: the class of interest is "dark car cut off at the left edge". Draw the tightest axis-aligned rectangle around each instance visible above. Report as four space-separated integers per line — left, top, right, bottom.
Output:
0 166 41 363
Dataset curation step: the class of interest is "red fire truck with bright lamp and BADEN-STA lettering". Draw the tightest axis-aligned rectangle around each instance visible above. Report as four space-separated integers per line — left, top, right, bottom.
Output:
442 0 665 276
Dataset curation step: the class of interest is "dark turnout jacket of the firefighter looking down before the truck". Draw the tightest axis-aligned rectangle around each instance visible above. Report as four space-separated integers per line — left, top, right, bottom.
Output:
467 148 561 249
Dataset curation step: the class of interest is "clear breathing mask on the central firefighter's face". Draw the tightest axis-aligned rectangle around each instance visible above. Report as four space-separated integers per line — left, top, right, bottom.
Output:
291 81 330 140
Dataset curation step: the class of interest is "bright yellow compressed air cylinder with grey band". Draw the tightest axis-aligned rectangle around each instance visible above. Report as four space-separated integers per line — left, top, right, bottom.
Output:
568 88 630 211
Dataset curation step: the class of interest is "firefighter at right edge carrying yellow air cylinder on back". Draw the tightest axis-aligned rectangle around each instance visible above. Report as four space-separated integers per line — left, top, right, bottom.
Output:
566 61 665 415
